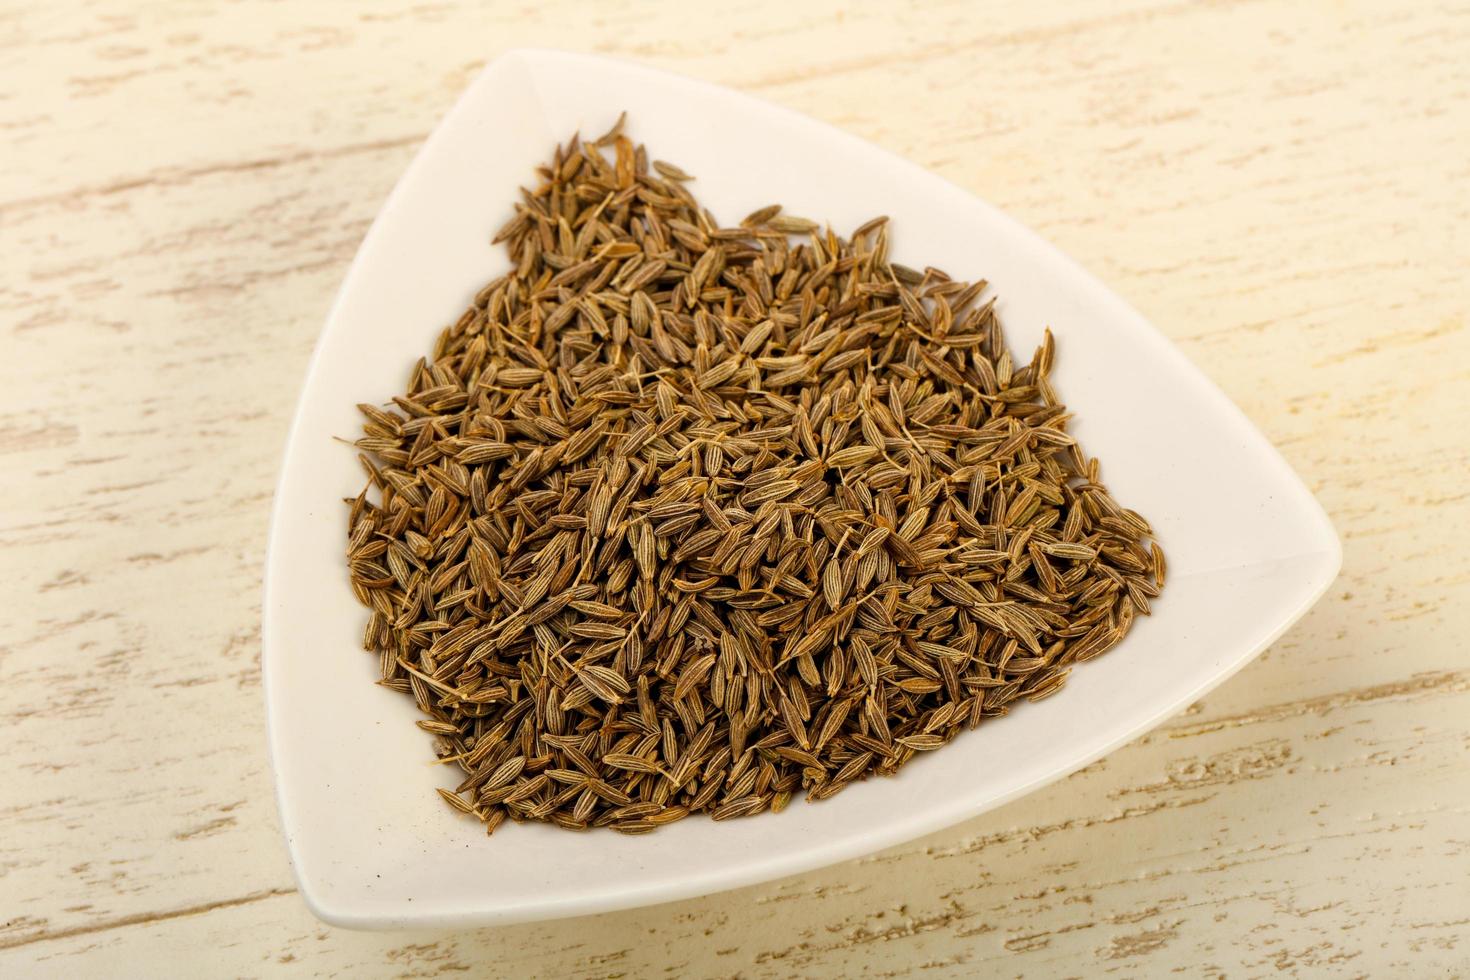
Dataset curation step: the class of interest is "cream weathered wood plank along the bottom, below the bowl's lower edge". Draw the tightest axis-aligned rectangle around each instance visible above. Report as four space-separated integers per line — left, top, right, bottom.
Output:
0 687 1470 977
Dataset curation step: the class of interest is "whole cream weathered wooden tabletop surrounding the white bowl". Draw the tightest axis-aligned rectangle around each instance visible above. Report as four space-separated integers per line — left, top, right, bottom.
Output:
0 0 1470 977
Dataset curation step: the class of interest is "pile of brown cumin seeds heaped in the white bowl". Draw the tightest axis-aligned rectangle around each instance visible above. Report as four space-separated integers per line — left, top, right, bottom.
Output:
347 115 1164 833
